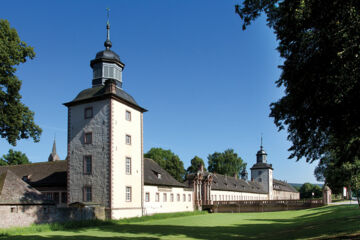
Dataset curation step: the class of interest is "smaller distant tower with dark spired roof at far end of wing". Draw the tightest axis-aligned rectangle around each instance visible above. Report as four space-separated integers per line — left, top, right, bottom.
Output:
250 137 273 200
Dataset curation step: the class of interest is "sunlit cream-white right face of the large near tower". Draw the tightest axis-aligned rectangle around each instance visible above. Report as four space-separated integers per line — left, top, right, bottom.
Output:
111 100 142 219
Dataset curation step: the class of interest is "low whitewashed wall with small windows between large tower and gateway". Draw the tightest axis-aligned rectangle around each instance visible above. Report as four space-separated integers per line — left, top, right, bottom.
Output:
144 185 194 215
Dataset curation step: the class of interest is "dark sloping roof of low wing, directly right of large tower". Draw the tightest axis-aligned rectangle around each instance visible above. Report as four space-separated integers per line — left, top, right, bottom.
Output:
144 158 186 187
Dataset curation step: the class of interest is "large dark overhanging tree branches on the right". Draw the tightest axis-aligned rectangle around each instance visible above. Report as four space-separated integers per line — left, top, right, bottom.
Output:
236 0 360 165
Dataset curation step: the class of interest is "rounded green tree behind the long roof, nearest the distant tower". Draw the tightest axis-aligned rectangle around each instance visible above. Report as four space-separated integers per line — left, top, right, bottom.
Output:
208 149 246 177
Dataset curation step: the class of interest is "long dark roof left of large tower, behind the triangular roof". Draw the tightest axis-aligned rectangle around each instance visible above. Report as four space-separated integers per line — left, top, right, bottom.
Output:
0 160 67 188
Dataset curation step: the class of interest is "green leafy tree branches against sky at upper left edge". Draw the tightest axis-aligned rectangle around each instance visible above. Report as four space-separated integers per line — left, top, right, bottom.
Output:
0 19 41 146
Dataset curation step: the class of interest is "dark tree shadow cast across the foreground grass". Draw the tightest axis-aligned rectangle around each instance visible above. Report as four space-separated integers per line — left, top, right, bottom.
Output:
0 206 360 240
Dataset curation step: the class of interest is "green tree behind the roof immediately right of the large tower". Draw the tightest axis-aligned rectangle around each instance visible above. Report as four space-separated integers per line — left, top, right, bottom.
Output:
144 148 185 182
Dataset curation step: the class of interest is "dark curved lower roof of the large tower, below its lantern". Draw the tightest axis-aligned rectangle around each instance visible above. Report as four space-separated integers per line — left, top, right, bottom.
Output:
64 85 147 112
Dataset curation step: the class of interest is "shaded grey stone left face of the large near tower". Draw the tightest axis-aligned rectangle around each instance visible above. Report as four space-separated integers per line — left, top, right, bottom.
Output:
68 100 110 207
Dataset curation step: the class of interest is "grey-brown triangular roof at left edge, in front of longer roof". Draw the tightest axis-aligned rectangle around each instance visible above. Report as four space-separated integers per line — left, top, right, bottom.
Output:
0 170 54 205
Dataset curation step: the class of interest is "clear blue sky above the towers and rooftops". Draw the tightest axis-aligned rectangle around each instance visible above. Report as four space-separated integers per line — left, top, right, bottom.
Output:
0 0 316 183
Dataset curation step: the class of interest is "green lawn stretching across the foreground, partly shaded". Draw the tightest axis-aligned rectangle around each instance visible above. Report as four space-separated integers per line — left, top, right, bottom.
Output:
0 205 360 240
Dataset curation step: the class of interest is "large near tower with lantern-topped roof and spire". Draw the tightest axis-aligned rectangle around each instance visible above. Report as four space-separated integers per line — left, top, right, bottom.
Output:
64 13 146 219
